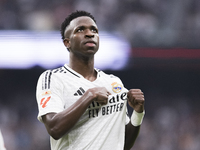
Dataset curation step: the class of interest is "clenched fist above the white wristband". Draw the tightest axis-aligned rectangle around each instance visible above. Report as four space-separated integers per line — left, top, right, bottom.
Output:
127 89 145 113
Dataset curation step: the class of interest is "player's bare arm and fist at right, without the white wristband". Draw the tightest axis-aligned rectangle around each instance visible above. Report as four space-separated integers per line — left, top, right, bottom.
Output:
124 89 144 150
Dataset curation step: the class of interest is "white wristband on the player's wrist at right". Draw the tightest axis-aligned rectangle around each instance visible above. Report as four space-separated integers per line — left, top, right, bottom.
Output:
131 110 145 127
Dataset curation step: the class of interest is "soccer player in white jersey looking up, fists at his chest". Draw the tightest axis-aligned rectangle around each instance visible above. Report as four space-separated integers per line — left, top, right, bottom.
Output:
36 11 144 150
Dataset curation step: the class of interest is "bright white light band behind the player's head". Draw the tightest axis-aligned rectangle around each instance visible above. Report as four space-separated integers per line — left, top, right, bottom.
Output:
0 31 131 70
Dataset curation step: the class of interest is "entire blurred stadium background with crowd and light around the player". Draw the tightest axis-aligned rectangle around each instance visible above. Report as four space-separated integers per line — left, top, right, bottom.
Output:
0 0 200 150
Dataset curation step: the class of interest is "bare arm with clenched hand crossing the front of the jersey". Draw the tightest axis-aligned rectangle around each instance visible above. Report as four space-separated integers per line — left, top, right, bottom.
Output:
42 87 110 139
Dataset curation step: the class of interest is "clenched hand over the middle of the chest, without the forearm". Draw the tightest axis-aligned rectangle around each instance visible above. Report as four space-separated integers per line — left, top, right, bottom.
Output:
89 87 111 105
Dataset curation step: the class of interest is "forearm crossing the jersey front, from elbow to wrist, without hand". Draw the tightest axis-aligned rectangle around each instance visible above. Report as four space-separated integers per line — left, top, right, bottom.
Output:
42 91 94 139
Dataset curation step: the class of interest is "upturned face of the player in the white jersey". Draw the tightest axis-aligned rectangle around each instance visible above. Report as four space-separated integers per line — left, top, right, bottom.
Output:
64 16 99 56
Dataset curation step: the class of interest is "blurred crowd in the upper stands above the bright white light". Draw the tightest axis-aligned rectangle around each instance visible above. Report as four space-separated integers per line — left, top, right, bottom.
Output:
0 0 200 48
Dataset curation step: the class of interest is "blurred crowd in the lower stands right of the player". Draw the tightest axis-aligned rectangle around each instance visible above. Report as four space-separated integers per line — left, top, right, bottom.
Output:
132 97 200 150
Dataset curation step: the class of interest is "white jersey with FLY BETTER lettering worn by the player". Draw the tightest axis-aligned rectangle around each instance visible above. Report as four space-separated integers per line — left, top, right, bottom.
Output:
36 65 130 150
